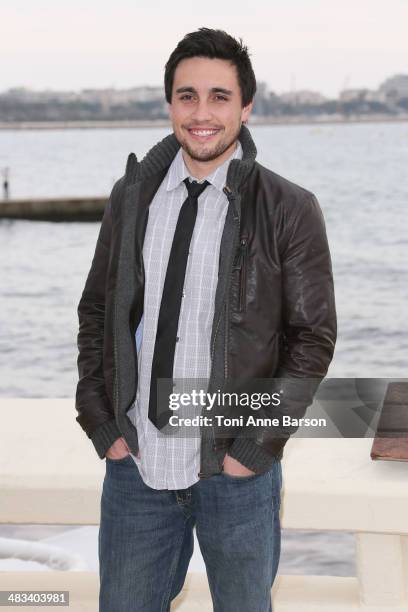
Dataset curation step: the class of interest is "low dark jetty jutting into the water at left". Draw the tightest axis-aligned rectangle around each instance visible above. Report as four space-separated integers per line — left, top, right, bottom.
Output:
0 196 108 221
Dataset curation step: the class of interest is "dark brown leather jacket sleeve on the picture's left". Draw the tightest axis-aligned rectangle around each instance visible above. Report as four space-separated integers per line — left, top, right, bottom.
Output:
75 181 120 444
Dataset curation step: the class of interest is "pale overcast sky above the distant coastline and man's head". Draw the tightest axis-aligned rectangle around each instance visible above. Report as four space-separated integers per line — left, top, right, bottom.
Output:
0 0 408 97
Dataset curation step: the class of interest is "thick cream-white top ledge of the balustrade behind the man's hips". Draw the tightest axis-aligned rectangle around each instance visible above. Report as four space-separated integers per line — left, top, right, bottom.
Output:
0 398 408 535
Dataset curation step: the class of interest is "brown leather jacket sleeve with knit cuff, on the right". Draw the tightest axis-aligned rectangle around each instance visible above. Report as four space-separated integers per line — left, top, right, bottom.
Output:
228 192 337 472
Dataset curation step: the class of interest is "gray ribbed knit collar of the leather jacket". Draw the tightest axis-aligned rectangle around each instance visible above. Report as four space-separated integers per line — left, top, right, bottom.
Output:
126 124 257 191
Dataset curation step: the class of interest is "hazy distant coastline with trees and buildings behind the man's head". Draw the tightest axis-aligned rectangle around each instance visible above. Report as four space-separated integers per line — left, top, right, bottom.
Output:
0 74 408 130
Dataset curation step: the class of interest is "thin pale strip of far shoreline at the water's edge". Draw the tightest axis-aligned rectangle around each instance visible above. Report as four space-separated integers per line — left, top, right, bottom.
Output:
0 113 408 130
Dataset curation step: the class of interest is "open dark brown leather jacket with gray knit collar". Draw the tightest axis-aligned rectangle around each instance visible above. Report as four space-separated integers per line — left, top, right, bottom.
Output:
76 126 336 476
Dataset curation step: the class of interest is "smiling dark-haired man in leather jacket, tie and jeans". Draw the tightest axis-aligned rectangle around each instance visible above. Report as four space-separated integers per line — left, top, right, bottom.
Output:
76 28 336 612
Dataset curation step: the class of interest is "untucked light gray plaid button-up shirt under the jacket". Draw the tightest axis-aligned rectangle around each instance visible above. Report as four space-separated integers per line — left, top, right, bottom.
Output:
128 141 242 489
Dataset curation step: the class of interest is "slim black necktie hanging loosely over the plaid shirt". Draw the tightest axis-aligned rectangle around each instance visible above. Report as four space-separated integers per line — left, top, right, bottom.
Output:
149 179 209 429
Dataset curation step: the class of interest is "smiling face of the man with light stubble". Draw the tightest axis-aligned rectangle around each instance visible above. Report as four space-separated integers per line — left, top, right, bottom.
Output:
169 57 252 162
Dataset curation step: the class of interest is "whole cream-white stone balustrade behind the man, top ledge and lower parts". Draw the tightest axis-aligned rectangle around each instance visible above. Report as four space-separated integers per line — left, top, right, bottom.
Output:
0 398 408 612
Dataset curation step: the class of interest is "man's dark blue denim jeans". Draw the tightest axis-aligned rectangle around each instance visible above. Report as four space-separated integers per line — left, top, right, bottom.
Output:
99 455 282 612
